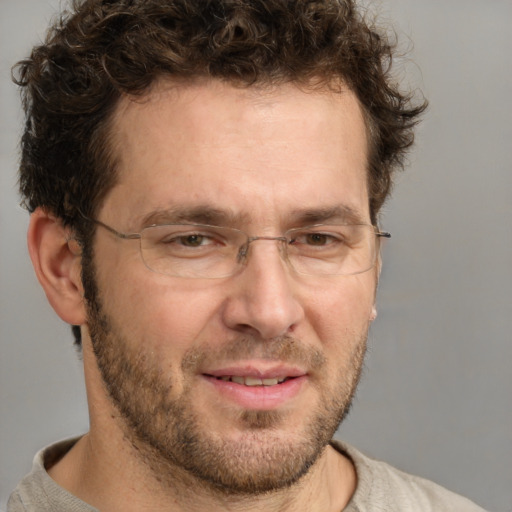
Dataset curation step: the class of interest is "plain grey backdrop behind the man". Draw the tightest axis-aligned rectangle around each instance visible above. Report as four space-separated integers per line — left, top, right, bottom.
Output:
0 0 512 512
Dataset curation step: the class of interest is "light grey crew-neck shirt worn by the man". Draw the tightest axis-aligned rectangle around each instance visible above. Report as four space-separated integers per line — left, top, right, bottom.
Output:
7 439 485 512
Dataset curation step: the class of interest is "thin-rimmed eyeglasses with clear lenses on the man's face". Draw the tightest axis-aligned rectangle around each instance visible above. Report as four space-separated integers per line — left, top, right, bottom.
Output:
84 215 391 279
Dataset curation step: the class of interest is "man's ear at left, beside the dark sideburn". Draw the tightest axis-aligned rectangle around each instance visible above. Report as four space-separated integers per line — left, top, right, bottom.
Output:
27 208 86 325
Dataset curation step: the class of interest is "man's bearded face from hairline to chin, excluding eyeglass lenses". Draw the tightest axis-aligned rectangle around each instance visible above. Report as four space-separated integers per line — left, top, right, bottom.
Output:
85 81 377 493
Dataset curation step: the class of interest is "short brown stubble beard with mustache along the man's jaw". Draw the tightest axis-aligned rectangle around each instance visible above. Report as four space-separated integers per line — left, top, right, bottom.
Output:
83 256 367 496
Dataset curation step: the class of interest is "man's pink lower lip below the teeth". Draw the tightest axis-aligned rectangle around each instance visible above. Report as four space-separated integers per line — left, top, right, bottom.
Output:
203 375 307 411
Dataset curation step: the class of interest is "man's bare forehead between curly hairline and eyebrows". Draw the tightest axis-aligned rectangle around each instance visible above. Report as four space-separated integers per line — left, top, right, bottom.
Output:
105 81 368 227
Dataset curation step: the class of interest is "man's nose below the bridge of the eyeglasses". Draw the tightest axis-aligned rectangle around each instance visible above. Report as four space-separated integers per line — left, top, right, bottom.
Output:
223 237 304 339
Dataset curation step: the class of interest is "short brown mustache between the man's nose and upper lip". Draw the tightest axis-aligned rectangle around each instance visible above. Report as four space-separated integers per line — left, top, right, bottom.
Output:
181 335 326 372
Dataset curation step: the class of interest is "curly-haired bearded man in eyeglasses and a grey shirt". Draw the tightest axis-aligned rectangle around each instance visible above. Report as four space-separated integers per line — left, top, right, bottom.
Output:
8 0 481 512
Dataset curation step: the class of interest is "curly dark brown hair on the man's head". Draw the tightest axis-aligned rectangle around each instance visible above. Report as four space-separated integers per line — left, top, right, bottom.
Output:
15 0 426 228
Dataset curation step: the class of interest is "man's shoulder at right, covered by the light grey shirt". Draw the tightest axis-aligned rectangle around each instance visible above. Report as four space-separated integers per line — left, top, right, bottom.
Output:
332 441 485 512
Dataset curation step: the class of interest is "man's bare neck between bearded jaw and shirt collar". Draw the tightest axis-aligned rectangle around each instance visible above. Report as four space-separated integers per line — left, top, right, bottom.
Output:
49 430 356 512
